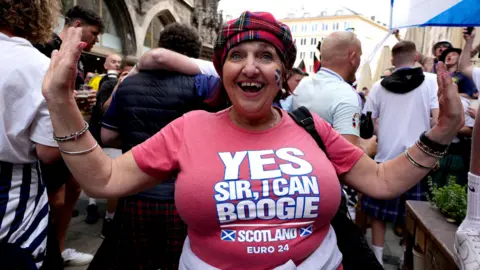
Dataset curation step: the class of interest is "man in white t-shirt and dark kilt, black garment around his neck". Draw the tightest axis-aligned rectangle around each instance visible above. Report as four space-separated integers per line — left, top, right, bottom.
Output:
362 41 439 263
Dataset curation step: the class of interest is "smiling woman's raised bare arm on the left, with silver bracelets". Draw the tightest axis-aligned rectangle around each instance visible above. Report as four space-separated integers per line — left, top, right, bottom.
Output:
42 28 161 198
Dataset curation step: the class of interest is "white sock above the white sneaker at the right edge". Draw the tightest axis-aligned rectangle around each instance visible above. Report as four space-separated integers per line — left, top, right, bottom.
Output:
460 173 480 229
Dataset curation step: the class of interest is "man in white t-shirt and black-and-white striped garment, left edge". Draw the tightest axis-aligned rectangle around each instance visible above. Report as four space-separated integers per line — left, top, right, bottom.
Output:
0 5 60 269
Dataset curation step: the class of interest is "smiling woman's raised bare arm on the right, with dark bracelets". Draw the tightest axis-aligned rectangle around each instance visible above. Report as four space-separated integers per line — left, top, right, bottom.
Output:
341 62 464 199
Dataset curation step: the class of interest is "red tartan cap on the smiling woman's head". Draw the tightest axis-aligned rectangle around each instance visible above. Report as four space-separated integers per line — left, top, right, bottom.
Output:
213 11 297 76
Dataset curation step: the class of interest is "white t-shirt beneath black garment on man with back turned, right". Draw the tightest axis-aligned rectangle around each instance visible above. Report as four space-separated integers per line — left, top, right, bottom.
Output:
363 73 438 162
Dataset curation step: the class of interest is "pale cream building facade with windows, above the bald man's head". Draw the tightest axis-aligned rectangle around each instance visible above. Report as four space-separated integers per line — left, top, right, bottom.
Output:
280 9 388 72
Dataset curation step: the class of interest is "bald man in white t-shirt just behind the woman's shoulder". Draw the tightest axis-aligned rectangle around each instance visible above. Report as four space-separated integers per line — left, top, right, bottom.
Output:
292 32 376 156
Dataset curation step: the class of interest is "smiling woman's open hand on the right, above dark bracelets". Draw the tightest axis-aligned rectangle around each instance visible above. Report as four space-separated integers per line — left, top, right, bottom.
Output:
427 62 465 144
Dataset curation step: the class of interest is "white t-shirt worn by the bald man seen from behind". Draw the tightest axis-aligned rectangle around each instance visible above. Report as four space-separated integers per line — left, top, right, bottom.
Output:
292 68 361 136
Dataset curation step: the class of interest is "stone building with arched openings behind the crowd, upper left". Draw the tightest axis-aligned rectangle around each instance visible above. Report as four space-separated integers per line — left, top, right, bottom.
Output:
56 0 222 72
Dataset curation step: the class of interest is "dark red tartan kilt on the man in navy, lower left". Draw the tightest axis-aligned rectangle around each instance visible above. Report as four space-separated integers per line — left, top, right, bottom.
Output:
88 197 187 270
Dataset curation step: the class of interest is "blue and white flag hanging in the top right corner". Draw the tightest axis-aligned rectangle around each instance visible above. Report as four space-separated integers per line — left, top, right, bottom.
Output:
390 0 480 29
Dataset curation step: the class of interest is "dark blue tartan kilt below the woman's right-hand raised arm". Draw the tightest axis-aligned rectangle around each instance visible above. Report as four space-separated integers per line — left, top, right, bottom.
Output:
362 177 428 224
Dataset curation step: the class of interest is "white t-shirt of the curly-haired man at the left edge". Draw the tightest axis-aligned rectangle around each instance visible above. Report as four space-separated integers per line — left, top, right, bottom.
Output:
0 33 57 164
